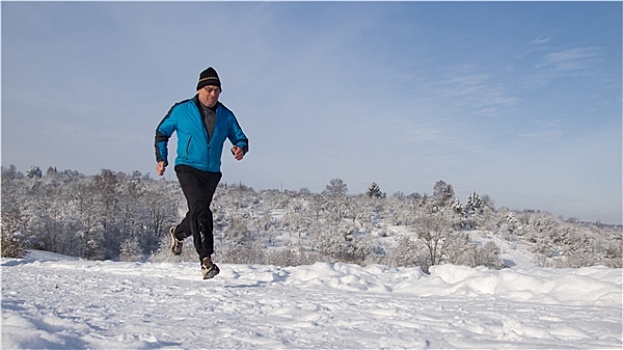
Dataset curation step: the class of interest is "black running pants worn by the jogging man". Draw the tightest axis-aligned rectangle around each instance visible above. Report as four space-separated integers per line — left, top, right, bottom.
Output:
175 165 222 261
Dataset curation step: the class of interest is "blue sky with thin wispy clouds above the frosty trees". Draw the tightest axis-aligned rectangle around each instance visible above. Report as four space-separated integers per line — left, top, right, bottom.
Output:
1 2 623 223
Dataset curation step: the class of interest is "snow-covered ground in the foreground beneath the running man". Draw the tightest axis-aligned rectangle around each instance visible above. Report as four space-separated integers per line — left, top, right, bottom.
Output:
2 252 623 349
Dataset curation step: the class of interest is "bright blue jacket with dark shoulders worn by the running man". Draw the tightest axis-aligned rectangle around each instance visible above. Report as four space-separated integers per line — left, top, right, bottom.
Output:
155 96 249 172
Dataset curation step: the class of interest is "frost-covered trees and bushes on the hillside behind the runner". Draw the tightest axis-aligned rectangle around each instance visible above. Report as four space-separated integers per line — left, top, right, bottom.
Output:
2 166 622 271
